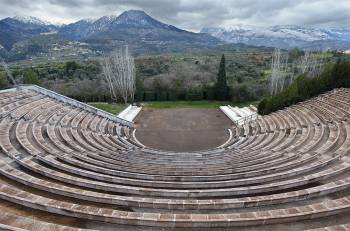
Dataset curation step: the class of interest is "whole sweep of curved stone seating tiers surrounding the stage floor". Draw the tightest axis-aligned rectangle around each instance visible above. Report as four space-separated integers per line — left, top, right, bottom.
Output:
0 86 350 231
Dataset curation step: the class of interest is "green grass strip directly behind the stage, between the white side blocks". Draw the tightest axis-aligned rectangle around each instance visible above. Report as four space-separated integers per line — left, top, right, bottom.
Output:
143 100 259 109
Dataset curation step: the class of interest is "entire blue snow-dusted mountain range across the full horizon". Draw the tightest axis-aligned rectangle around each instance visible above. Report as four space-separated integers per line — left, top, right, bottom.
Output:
0 10 350 61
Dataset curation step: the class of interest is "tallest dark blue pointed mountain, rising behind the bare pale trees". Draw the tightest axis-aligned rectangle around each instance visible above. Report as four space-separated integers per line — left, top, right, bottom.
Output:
59 10 222 52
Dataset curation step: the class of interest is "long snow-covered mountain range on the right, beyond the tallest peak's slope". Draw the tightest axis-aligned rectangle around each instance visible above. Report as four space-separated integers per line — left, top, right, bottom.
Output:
201 25 350 49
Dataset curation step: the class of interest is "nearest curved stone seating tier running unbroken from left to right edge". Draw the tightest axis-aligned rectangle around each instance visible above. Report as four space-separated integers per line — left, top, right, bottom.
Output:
0 179 350 228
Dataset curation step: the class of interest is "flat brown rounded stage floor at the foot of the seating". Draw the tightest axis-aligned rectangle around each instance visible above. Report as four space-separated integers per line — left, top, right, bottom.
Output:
136 108 232 152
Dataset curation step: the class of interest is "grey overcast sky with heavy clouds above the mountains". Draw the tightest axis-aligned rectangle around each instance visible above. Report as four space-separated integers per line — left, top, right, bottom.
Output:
0 0 350 31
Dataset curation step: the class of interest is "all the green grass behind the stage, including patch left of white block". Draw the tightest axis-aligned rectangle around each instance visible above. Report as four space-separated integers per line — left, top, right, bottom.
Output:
89 101 258 114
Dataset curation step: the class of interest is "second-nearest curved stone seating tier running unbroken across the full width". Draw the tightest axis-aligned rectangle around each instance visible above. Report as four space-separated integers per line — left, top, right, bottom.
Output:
0 159 350 210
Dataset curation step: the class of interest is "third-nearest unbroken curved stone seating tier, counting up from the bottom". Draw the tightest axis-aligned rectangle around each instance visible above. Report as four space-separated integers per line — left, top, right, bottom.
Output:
12 152 350 198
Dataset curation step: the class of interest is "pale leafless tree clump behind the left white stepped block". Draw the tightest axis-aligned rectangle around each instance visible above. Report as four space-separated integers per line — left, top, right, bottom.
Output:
101 46 136 104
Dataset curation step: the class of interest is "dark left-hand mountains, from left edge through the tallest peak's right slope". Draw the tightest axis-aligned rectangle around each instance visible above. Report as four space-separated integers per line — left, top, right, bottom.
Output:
0 10 223 58
